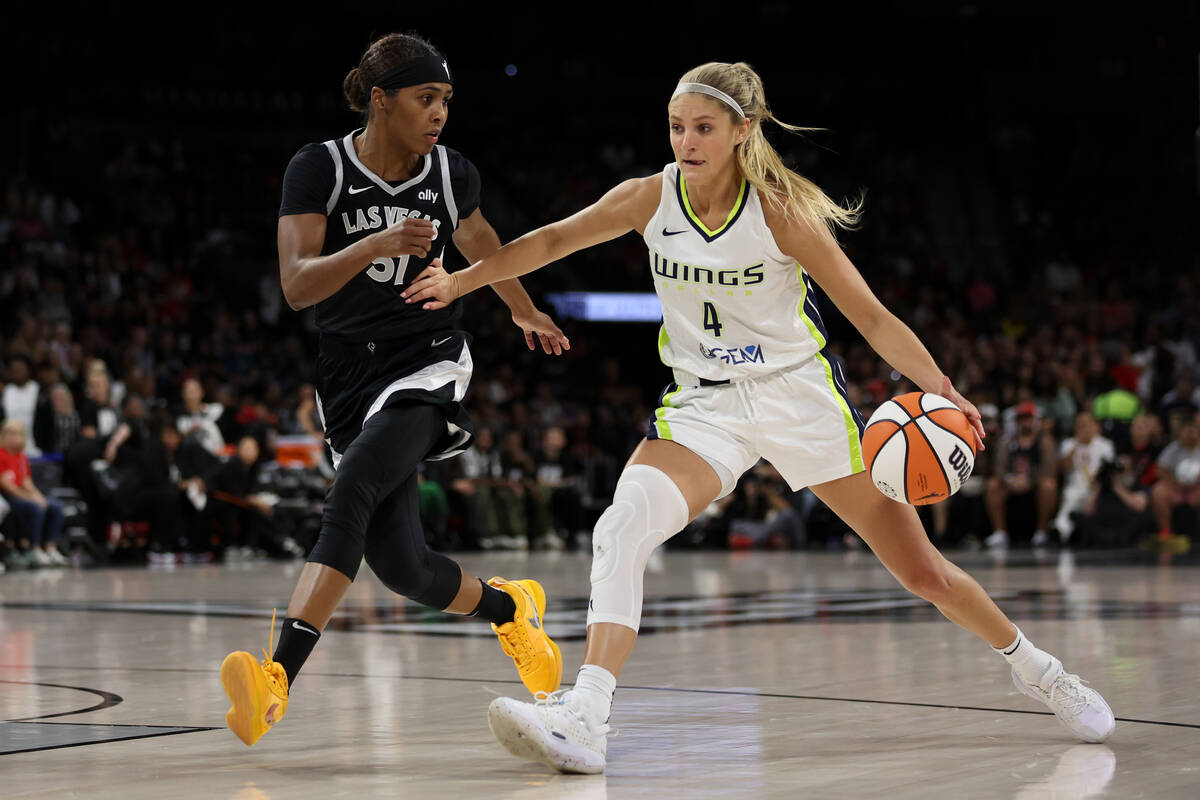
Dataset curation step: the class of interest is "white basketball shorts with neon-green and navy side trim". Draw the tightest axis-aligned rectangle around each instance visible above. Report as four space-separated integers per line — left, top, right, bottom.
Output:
647 354 864 497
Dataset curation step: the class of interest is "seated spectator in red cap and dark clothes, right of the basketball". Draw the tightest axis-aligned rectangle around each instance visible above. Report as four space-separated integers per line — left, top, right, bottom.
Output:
985 402 1058 549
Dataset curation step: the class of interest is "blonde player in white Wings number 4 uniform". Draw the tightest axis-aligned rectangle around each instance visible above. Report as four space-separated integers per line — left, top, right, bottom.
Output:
404 64 1115 772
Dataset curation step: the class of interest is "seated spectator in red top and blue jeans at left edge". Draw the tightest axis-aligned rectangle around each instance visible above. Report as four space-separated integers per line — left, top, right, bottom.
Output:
0 419 67 566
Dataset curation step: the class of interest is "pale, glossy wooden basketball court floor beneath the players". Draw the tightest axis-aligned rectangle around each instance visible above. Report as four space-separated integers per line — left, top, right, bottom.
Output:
0 551 1200 800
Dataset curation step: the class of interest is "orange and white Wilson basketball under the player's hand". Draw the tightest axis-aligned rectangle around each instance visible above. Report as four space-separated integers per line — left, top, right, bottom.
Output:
863 392 976 505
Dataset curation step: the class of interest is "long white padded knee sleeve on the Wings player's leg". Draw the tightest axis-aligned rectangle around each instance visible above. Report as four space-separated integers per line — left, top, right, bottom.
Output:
588 464 690 631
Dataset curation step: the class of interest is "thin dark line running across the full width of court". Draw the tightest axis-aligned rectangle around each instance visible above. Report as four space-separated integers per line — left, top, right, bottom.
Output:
0 664 1200 730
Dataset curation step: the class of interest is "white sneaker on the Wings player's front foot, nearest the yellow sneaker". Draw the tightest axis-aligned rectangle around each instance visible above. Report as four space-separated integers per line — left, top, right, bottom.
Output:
487 688 608 774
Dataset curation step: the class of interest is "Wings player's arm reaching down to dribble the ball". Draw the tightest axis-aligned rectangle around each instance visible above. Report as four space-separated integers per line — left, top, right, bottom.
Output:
763 203 985 449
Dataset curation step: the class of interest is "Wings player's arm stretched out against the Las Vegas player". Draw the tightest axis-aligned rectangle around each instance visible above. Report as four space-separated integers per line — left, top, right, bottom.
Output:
403 175 662 309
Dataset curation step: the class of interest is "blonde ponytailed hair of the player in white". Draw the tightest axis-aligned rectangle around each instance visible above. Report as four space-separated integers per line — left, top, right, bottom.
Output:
679 61 863 234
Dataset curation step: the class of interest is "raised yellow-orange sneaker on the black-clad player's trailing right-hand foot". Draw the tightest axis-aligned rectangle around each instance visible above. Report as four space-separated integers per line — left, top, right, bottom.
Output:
487 577 563 694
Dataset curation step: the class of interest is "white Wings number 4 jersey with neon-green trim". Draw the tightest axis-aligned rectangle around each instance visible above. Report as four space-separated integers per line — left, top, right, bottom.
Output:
644 163 826 380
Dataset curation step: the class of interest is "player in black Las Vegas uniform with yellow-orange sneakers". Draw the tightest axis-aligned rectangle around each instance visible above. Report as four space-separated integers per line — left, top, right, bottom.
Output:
221 34 570 745
